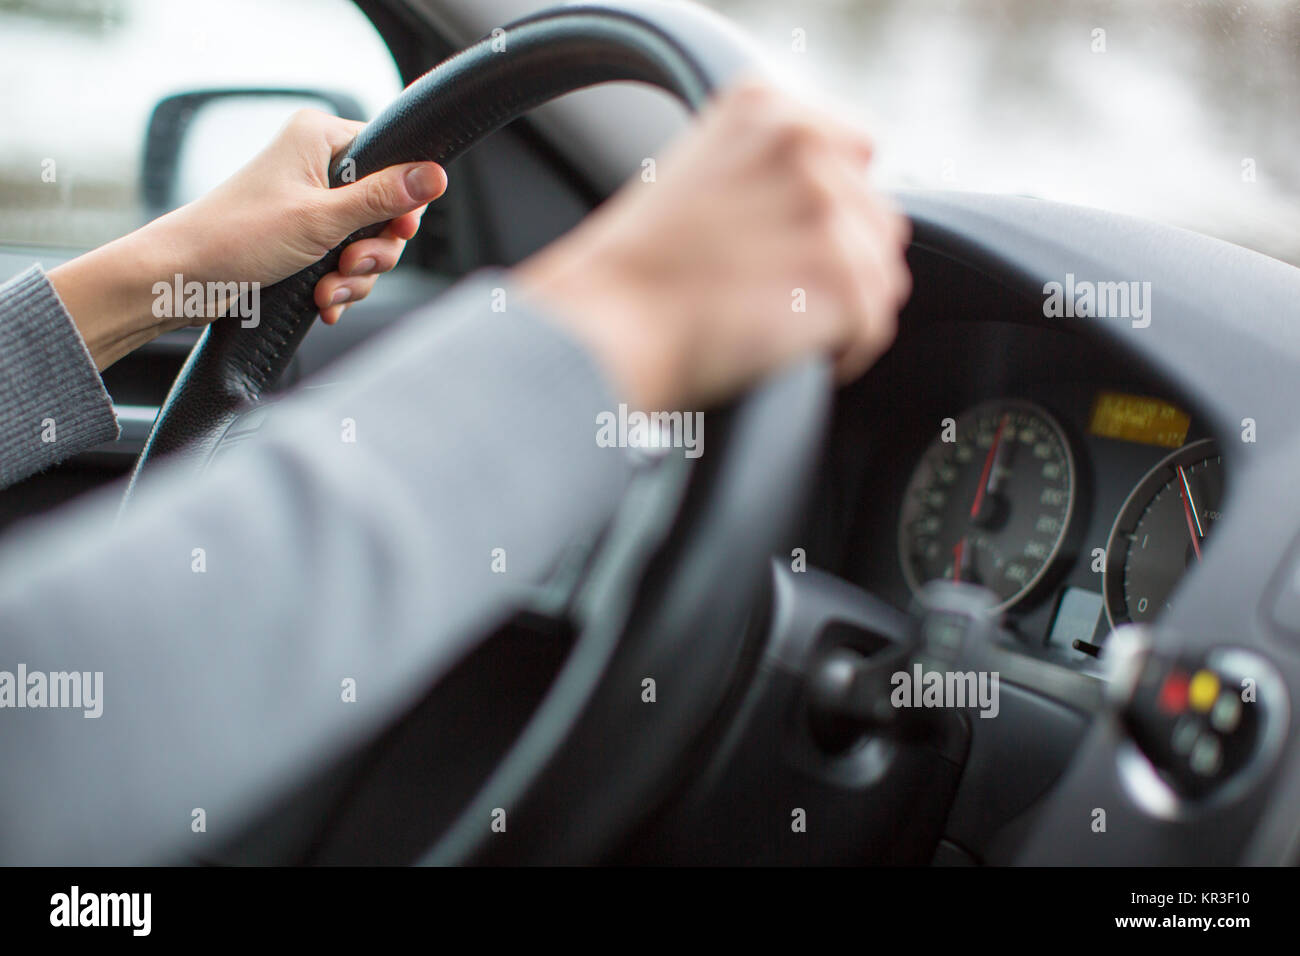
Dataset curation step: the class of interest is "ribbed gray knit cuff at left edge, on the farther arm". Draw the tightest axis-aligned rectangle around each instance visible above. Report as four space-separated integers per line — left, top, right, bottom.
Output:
0 265 118 488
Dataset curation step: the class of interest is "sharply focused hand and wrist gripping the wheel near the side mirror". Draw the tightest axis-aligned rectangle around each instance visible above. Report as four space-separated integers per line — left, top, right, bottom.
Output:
49 109 447 368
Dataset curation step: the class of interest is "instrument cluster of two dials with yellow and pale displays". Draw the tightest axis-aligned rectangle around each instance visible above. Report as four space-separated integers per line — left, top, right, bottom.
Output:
897 389 1225 657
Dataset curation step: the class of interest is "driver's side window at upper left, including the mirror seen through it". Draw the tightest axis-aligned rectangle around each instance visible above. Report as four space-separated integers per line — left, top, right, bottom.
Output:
0 0 402 251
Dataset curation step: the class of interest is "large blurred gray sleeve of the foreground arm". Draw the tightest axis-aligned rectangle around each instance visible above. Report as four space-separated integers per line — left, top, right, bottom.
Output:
0 272 632 865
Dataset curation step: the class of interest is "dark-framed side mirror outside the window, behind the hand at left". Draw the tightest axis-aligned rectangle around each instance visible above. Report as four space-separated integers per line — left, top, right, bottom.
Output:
140 88 365 219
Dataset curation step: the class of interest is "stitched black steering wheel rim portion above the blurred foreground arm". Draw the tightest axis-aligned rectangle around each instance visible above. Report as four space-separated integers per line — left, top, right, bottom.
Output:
124 0 755 494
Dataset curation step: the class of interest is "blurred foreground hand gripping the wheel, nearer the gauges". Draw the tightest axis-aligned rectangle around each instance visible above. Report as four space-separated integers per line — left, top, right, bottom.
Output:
516 82 911 410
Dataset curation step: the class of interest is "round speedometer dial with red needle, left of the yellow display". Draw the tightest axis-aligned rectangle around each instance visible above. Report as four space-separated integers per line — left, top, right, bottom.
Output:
898 399 1075 609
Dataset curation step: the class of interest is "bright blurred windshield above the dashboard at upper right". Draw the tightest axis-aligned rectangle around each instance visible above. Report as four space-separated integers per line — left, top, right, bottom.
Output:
706 0 1300 265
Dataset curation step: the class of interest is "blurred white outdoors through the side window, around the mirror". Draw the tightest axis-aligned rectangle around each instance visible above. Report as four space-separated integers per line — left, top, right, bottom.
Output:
0 0 402 250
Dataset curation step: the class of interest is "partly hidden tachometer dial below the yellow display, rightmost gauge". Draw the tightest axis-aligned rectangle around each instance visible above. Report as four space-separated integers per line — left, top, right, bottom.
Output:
1102 438 1223 627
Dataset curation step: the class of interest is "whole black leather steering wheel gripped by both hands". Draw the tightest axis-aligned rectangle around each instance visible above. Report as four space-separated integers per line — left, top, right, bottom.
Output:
125 0 829 864
